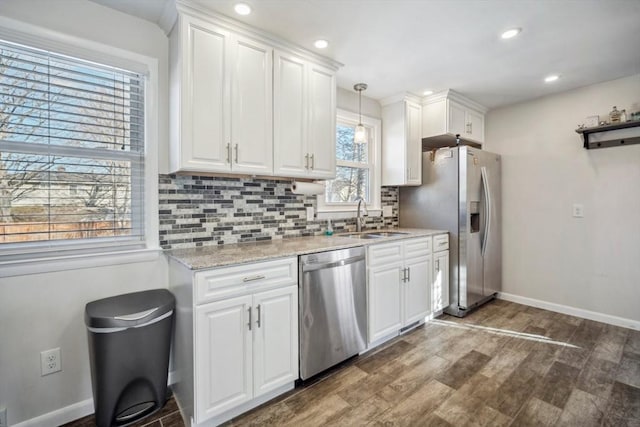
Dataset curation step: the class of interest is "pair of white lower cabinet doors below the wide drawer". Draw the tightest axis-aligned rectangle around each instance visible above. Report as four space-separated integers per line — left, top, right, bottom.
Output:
195 286 298 422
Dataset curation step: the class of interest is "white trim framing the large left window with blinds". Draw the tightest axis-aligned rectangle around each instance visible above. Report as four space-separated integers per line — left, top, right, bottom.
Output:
0 16 160 277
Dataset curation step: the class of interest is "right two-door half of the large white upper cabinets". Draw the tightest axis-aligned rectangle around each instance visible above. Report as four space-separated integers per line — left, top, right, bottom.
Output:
273 51 336 179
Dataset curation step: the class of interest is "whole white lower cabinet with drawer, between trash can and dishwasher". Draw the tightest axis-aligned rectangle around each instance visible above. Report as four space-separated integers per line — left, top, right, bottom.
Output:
169 257 298 427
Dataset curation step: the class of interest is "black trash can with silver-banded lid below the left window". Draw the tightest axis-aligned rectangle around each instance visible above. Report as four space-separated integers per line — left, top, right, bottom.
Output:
84 289 176 427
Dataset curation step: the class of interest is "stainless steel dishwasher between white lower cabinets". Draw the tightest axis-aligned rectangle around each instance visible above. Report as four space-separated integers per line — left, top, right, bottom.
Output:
299 247 367 380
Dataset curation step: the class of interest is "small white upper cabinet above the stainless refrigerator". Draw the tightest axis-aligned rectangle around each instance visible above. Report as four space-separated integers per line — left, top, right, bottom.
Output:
422 90 486 144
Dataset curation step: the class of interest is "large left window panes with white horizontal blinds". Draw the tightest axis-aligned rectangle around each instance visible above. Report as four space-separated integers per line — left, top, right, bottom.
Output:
0 41 145 253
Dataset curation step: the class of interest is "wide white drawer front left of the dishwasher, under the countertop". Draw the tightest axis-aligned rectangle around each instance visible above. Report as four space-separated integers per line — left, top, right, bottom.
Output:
194 257 298 304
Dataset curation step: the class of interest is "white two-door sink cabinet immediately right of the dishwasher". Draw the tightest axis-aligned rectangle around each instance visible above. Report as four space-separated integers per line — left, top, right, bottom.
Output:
368 237 432 343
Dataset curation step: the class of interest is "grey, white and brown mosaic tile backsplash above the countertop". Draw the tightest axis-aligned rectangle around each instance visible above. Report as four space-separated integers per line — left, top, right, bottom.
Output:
159 175 398 249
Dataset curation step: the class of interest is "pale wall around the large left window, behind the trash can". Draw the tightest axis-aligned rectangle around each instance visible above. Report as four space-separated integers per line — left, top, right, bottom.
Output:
0 0 168 425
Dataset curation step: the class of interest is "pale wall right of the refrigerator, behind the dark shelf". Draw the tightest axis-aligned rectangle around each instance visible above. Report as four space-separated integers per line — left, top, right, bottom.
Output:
483 74 640 324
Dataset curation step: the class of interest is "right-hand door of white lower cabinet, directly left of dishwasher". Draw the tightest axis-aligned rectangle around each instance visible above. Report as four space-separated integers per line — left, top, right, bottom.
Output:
253 286 298 397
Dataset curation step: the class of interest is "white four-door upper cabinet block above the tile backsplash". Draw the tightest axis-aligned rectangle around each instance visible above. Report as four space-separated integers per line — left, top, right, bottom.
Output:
169 8 338 178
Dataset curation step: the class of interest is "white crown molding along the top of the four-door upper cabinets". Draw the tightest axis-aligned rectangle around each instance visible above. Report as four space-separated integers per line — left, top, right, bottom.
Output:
175 0 344 71
